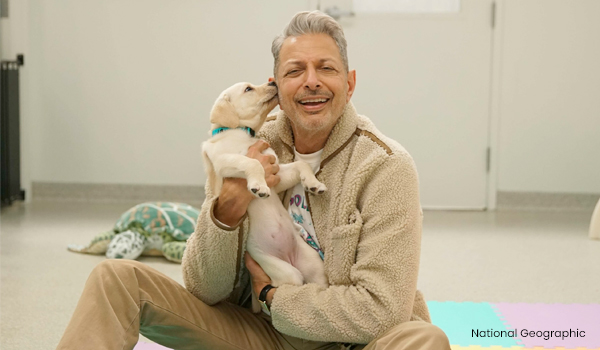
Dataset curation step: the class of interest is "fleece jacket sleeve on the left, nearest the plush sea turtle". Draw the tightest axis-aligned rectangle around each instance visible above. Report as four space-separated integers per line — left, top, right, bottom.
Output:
182 193 248 305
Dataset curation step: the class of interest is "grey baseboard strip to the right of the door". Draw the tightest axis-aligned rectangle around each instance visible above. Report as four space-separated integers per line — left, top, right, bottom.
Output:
497 191 600 211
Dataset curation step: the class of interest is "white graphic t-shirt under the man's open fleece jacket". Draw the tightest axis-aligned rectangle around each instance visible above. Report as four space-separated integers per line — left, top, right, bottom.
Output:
288 149 325 259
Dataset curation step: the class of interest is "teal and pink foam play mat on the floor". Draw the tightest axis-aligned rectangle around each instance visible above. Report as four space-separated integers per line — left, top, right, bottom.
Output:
134 301 600 350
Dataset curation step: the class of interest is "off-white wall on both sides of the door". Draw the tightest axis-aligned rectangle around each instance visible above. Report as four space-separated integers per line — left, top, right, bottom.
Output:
11 0 600 200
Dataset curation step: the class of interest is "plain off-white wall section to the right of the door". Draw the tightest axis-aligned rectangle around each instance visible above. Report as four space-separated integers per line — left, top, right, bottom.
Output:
497 0 600 193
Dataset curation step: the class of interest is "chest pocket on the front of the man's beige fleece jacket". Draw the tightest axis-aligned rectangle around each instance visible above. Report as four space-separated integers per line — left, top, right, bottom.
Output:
325 209 363 285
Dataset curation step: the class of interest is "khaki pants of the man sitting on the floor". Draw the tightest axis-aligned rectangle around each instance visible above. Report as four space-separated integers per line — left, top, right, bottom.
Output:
57 260 450 350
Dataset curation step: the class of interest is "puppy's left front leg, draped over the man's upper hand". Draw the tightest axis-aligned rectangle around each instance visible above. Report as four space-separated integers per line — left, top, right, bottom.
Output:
213 154 271 198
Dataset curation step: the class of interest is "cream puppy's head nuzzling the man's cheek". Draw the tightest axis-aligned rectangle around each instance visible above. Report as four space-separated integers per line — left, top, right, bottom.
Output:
210 83 279 131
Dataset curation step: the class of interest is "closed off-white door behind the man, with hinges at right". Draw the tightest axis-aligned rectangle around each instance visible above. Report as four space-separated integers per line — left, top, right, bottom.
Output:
311 0 493 209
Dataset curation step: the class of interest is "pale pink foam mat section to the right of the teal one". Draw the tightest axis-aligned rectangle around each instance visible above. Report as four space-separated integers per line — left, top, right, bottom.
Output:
492 303 600 349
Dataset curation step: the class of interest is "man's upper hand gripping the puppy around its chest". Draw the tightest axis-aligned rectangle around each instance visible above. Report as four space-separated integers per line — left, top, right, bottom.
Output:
214 140 280 226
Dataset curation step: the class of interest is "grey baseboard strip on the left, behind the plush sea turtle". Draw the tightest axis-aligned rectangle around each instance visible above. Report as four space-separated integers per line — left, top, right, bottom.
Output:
32 182 204 205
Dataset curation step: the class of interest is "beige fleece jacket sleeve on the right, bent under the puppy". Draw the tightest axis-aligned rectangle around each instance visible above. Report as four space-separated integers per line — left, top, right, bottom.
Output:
271 153 422 344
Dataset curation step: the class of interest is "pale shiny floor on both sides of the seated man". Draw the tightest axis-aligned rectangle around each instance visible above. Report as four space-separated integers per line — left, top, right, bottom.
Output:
0 202 600 350
